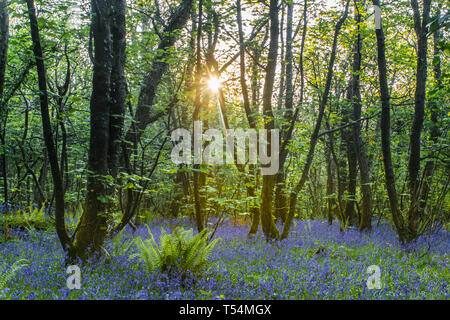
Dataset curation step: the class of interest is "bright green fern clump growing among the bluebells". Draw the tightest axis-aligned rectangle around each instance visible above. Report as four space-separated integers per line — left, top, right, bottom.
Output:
131 226 219 278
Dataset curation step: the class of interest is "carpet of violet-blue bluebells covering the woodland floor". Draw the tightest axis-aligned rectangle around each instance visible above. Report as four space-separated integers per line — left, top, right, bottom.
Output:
0 220 450 300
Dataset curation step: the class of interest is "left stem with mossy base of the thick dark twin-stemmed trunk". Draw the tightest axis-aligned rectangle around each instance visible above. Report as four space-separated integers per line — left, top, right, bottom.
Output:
76 0 112 258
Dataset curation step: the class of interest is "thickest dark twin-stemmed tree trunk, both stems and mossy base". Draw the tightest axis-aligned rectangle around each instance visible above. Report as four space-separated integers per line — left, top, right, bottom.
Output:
76 0 126 259
